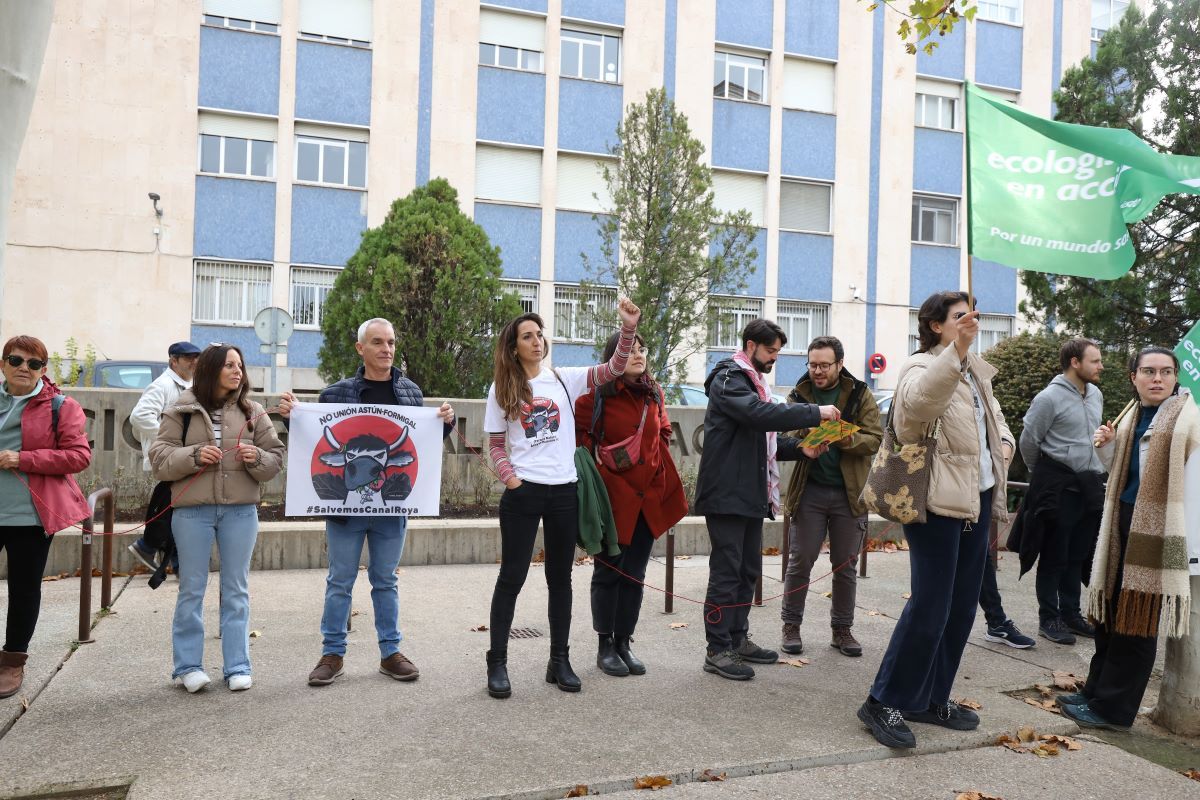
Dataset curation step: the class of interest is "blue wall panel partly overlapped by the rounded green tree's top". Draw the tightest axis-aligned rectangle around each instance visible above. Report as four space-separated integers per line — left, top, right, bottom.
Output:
292 186 367 266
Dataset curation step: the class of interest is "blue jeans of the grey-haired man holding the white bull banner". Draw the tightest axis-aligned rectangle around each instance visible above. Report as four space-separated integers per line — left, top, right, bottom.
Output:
320 517 408 660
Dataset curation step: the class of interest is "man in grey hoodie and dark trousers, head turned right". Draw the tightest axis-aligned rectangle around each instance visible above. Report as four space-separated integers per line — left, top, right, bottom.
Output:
1020 338 1104 644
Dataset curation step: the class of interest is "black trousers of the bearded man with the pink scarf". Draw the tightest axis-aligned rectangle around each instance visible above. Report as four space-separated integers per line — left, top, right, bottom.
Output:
704 513 762 652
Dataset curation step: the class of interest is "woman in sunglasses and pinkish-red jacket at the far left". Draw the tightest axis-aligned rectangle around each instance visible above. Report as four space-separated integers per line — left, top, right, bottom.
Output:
0 336 91 697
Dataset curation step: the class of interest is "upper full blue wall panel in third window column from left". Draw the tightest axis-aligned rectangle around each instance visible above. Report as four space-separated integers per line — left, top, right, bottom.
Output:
475 67 546 148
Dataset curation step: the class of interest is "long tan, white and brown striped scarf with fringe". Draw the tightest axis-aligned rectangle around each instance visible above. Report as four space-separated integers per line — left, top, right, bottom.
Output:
1088 395 1200 638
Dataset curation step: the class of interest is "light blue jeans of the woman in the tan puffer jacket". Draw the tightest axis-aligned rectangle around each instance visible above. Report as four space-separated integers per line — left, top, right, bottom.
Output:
170 504 258 679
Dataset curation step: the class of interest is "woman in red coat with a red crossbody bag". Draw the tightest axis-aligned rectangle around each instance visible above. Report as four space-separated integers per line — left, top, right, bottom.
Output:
575 333 688 676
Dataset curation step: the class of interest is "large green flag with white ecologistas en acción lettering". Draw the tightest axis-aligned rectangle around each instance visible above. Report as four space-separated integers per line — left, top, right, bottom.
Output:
967 83 1200 279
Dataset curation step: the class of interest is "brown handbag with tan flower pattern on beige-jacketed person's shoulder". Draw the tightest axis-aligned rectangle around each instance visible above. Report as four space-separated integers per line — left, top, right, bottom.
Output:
859 399 942 525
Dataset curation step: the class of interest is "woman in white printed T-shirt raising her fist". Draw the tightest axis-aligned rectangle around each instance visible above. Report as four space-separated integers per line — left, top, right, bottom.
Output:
484 297 642 697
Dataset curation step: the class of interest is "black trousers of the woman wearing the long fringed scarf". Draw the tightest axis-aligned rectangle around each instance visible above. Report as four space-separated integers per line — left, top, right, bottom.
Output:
1084 503 1158 724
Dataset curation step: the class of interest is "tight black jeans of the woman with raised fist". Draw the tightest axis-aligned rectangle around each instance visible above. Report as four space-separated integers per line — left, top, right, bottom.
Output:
491 481 580 652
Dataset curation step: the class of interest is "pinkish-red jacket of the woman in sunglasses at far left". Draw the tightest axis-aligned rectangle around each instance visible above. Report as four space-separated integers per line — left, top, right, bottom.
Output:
19 375 91 534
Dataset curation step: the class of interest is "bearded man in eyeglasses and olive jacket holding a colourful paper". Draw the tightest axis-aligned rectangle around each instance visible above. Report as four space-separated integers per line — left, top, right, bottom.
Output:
780 336 883 656
